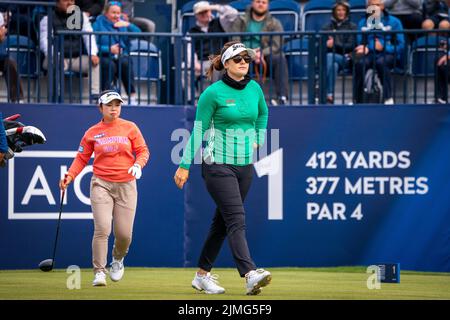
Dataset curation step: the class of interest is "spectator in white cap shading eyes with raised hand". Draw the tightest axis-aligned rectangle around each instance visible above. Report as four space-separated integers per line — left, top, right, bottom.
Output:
182 1 239 100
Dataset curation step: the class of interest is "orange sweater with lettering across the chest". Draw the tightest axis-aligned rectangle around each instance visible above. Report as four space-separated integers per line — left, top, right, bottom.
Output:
68 118 150 182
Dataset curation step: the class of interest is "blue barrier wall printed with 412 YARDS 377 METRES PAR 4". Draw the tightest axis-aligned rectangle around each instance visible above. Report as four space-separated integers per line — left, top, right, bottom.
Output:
0 104 450 272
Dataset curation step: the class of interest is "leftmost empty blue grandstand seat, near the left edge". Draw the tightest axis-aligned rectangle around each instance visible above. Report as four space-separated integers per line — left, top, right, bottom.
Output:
5 35 38 78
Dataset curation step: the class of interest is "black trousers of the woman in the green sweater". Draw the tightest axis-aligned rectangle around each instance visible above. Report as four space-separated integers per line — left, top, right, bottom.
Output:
198 162 256 277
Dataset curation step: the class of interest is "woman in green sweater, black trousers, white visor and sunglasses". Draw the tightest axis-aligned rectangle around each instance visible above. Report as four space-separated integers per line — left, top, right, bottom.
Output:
174 41 272 295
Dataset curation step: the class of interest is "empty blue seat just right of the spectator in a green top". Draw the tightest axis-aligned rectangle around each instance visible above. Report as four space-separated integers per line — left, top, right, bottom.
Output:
283 38 309 80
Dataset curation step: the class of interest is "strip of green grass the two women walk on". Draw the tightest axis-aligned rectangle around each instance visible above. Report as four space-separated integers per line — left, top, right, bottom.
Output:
0 267 450 300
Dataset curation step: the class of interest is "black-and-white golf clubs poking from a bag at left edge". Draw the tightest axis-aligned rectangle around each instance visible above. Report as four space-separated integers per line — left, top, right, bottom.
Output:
0 114 47 167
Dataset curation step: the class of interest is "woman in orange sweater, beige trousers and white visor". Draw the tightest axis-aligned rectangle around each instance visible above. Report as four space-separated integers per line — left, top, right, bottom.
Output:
59 90 149 286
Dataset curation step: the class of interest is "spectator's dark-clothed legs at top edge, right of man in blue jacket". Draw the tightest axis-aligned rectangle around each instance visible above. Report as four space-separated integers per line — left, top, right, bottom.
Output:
384 0 423 36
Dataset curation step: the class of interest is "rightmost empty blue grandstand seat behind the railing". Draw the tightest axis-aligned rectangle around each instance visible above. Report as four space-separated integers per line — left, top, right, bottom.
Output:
408 36 447 77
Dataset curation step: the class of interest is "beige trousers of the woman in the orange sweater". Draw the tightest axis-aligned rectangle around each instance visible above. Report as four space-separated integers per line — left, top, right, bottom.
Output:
91 175 137 273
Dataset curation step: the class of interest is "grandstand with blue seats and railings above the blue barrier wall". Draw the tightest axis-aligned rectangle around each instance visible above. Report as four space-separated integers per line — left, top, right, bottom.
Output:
0 0 449 106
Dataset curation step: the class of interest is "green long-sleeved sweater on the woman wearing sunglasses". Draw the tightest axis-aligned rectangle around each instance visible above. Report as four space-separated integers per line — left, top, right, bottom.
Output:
180 80 268 169
